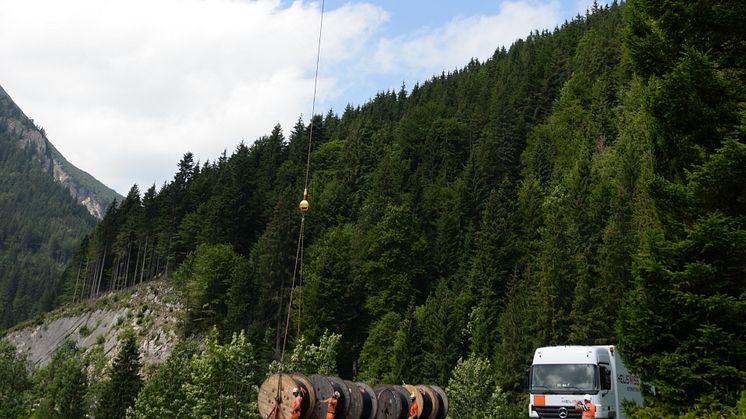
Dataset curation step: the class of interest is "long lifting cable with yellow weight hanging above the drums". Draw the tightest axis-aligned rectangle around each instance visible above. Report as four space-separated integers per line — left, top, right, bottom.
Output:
277 0 324 382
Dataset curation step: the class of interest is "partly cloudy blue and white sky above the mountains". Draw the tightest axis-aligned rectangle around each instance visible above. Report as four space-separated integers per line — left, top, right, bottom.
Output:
0 0 606 195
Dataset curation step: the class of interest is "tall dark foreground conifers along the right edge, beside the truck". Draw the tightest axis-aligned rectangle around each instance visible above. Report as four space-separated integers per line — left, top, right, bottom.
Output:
618 1 746 417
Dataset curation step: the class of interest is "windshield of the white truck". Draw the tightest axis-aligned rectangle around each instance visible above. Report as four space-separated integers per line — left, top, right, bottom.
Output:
531 364 597 393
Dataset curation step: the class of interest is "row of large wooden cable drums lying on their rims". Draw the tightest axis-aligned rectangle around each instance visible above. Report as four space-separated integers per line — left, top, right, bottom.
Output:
259 373 448 419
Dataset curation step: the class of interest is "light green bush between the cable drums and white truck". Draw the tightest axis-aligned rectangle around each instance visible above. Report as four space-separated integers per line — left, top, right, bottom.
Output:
446 355 514 419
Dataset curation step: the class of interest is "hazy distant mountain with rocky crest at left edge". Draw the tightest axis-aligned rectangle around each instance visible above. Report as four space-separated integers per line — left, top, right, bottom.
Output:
0 83 116 328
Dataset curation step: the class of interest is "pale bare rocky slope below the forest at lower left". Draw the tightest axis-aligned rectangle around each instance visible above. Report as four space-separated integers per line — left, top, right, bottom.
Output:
5 280 184 366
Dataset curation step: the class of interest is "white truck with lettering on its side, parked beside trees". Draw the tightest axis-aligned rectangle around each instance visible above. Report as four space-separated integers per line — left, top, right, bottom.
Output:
528 345 642 419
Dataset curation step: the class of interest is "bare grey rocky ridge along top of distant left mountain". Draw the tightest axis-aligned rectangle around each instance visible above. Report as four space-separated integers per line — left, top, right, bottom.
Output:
0 86 121 219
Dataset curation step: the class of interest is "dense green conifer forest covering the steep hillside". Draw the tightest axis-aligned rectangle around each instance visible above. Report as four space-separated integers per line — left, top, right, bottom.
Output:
2 0 746 417
